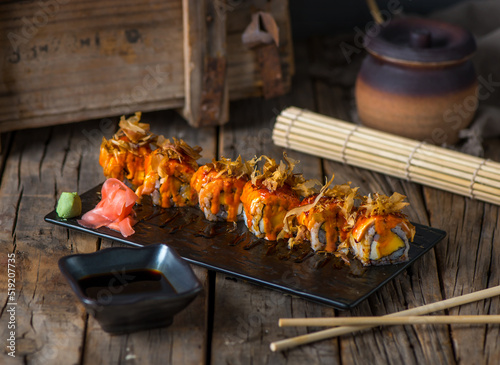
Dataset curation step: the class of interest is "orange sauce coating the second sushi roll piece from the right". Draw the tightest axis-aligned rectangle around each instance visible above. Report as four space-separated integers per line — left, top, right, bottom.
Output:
297 194 349 252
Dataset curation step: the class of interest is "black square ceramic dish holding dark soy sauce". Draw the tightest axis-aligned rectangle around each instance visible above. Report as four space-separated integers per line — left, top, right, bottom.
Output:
59 244 202 334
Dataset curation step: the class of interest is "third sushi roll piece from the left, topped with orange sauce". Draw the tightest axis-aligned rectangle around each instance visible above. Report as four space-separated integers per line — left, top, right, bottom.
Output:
191 156 256 222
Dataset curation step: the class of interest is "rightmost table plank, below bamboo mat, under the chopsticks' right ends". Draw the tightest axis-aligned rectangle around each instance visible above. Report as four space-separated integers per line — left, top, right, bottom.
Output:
424 188 500 364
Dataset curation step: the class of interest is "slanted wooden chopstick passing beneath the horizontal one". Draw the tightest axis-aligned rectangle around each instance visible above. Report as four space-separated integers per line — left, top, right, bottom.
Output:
270 285 500 351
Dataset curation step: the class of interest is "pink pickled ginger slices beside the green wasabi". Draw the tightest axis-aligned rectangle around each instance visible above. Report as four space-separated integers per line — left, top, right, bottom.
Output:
78 178 138 237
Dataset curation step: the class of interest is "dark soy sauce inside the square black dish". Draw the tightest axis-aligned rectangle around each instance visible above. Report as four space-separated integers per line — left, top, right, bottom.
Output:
78 269 176 301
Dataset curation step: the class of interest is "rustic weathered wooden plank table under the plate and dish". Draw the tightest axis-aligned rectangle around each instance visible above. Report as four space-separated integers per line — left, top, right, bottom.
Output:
0 39 500 365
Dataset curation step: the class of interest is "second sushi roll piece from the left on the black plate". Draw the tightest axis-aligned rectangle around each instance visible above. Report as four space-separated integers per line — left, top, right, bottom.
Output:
135 136 201 208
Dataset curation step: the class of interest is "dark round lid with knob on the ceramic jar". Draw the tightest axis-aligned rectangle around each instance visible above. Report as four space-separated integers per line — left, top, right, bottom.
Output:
365 18 476 63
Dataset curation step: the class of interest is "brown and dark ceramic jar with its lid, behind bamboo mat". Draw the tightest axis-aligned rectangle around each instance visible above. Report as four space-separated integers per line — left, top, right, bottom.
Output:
356 18 478 145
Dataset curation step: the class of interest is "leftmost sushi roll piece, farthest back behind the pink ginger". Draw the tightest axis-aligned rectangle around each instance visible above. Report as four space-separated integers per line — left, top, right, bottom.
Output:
99 112 156 187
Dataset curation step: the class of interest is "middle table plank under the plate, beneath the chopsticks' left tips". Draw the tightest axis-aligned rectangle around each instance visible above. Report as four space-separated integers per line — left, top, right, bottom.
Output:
211 44 339 364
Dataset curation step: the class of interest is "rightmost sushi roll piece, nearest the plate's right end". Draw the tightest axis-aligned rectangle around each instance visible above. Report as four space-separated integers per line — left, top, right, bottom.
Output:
350 193 415 266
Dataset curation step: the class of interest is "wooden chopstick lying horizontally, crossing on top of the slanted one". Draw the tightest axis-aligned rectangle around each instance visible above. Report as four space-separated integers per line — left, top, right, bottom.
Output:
279 315 500 327
